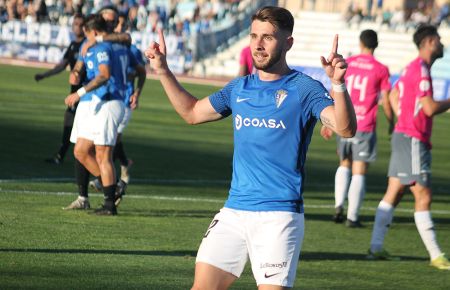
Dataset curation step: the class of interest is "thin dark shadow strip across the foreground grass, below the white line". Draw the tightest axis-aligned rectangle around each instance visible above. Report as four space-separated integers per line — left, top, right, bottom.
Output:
0 249 428 262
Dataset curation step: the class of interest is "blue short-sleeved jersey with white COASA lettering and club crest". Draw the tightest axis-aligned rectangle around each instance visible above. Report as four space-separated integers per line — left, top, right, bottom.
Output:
209 71 333 212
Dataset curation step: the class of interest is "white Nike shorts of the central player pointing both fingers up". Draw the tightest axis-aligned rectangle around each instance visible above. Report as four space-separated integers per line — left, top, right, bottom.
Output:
196 208 304 287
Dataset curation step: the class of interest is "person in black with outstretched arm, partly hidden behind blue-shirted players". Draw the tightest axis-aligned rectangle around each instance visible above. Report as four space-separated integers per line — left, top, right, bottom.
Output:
34 14 85 164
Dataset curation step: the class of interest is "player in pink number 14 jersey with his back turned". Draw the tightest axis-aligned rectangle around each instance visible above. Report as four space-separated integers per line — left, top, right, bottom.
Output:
324 30 393 228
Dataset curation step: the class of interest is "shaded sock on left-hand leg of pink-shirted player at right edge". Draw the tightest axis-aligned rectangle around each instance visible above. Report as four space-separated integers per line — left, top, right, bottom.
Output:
370 200 394 253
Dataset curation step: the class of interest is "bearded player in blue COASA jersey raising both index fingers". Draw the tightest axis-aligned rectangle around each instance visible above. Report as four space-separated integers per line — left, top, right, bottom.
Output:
145 6 356 289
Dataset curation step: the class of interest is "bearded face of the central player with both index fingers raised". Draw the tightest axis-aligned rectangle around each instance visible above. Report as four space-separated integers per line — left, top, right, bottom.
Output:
250 20 292 71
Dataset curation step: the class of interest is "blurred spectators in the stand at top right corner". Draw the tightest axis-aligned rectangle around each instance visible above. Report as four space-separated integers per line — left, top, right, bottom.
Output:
344 0 450 31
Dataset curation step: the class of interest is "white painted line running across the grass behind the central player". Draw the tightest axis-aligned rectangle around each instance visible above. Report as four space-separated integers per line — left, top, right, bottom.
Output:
0 188 450 215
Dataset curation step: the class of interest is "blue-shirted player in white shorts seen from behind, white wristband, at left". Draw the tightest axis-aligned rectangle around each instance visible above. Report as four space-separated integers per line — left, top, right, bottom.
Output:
66 15 136 215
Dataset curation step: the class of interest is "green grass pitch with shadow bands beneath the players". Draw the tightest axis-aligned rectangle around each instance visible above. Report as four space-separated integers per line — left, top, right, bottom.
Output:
0 65 450 290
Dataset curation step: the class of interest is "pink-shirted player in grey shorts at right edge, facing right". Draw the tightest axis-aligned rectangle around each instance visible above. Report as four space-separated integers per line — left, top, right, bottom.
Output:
367 25 450 270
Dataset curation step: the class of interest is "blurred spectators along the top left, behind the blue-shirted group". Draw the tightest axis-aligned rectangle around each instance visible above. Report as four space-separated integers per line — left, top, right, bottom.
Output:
0 0 251 36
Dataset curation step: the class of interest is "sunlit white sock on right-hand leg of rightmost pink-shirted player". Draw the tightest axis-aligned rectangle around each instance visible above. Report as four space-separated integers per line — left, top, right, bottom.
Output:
414 211 442 260
